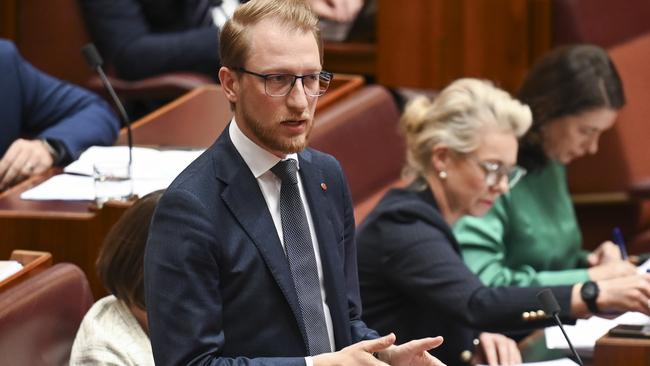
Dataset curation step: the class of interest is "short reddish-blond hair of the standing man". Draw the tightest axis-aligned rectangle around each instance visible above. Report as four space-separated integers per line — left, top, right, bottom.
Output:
219 0 323 68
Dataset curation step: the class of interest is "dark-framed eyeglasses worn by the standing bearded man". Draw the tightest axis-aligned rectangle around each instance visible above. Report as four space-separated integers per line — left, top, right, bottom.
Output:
235 67 334 97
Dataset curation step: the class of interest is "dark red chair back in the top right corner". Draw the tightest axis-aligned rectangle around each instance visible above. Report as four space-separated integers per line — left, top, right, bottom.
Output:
553 0 650 47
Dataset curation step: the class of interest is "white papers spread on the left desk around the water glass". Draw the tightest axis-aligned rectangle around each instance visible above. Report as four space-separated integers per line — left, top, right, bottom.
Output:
20 146 203 200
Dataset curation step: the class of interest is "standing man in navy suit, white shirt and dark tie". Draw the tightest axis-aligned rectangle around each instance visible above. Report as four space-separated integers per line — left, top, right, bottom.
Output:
145 0 442 366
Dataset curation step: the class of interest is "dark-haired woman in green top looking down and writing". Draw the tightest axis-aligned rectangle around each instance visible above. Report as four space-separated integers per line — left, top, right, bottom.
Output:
454 45 635 292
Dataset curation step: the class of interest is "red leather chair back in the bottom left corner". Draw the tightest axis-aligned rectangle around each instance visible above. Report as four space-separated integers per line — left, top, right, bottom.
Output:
0 263 93 366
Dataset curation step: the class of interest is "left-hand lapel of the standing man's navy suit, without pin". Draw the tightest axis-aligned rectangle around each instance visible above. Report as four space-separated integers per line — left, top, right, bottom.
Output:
214 133 307 345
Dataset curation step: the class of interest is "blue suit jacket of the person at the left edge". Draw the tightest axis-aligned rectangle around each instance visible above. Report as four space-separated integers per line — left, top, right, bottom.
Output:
0 39 119 163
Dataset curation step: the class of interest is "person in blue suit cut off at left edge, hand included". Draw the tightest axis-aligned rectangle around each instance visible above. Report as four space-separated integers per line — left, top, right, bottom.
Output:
0 39 119 192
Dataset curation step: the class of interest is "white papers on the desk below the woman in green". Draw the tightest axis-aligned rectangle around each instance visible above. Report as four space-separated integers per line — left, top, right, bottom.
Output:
544 312 650 356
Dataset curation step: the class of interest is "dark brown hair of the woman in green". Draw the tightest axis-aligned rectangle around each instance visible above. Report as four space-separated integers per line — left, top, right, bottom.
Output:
517 45 625 172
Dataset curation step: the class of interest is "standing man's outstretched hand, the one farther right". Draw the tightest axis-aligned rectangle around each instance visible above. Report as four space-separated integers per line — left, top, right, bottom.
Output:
379 333 444 366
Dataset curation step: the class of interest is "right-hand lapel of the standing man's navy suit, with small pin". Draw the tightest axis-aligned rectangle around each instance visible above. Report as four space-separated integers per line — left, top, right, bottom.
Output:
299 151 350 349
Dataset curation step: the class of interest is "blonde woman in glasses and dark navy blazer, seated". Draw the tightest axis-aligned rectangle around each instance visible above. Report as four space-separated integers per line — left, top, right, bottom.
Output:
357 79 650 365
